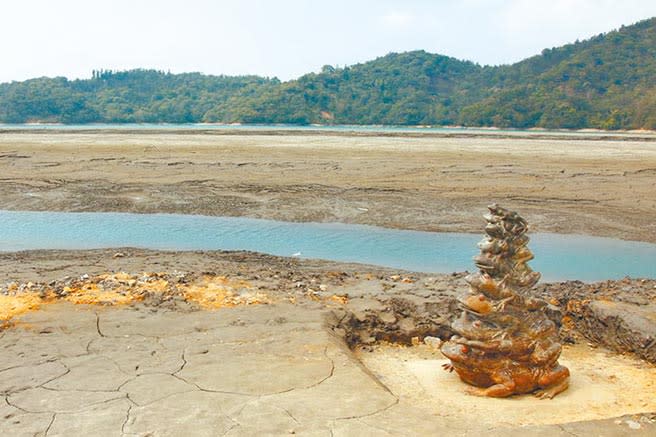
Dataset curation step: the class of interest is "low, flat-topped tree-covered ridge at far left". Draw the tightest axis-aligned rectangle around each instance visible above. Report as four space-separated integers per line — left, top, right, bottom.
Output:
0 70 280 123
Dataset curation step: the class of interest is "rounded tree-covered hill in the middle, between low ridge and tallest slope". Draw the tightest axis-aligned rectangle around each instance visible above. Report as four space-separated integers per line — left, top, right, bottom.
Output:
223 51 480 125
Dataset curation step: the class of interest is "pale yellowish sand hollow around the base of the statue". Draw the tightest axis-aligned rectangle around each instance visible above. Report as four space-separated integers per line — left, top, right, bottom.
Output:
358 345 656 427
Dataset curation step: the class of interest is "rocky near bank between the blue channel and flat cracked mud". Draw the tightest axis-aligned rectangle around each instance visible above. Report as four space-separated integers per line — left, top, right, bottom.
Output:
0 247 656 364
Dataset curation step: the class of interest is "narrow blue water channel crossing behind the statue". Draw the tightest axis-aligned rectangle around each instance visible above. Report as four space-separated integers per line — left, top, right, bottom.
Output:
0 211 656 281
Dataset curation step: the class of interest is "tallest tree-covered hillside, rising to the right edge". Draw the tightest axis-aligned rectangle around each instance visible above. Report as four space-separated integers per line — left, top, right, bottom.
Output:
459 18 656 129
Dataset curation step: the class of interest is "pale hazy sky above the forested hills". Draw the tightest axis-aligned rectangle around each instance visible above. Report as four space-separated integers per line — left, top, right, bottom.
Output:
0 0 656 82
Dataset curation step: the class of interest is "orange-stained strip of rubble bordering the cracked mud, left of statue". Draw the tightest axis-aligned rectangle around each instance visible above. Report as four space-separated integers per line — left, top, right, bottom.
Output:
0 255 359 328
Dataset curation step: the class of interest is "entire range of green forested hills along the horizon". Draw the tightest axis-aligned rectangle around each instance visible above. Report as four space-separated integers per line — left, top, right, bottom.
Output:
0 18 656 129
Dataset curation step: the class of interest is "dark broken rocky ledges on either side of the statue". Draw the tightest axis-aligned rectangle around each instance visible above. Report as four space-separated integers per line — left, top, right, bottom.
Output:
330 250 656 363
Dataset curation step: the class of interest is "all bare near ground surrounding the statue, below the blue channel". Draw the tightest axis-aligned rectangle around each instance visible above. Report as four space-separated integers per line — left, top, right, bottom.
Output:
0 248 656 436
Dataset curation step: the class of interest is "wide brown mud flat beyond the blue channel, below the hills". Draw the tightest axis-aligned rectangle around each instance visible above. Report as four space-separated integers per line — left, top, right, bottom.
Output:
0 131 656 242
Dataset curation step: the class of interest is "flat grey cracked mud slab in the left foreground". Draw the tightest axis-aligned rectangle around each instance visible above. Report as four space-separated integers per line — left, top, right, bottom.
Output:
0 303 396 436
